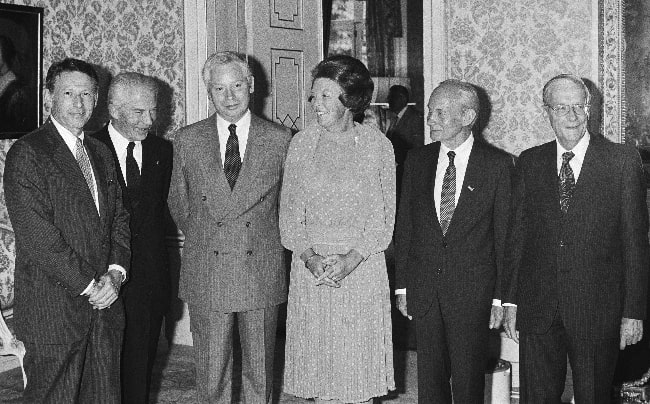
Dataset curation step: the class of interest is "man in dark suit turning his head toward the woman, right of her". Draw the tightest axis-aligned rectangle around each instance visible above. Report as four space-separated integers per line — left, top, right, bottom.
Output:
395 80 512 404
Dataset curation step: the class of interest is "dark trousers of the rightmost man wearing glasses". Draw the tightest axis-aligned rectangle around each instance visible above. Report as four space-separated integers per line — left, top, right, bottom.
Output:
519 313 619 404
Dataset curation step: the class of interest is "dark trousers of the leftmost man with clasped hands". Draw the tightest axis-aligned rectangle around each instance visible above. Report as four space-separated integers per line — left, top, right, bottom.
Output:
23 311 123 404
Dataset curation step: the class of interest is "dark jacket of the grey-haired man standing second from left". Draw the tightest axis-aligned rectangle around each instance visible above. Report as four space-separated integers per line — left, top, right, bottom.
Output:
93 125 172 311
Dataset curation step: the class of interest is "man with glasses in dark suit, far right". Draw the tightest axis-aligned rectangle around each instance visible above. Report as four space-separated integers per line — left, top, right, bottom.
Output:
504 75 650 403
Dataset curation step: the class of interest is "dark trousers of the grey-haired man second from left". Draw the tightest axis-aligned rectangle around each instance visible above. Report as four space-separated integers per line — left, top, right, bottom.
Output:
122 291 165 404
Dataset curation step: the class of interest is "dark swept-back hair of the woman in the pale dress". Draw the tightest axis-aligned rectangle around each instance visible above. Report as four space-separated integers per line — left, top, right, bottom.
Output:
311 55 375 114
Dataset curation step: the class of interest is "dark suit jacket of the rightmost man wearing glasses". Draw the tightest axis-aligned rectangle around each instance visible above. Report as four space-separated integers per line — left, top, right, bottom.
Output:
505 135 650 338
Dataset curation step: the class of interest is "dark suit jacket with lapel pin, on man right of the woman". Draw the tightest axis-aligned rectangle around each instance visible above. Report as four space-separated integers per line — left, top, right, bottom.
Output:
395 140 512 318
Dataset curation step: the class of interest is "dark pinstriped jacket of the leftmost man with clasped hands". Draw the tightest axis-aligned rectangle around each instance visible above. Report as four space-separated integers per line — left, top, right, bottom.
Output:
4 121 130 344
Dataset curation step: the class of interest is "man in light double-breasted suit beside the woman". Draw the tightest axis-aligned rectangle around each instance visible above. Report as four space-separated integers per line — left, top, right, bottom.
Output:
169 52 291 403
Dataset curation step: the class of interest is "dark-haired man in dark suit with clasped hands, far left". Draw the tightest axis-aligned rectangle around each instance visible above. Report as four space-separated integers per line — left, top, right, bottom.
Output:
4 59 130 403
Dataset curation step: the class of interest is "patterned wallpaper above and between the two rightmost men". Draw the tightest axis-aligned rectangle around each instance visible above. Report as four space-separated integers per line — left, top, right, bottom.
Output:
446 0 597 155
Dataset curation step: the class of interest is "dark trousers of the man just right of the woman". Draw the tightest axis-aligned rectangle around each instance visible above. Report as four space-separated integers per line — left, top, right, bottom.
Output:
406 287 491 404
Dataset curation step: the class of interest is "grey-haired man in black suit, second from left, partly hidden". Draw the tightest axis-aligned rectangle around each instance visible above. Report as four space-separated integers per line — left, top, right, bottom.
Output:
94 72 172 404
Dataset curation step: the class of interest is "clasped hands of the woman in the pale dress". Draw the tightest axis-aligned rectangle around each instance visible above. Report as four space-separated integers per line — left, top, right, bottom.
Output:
305 250 363 288
